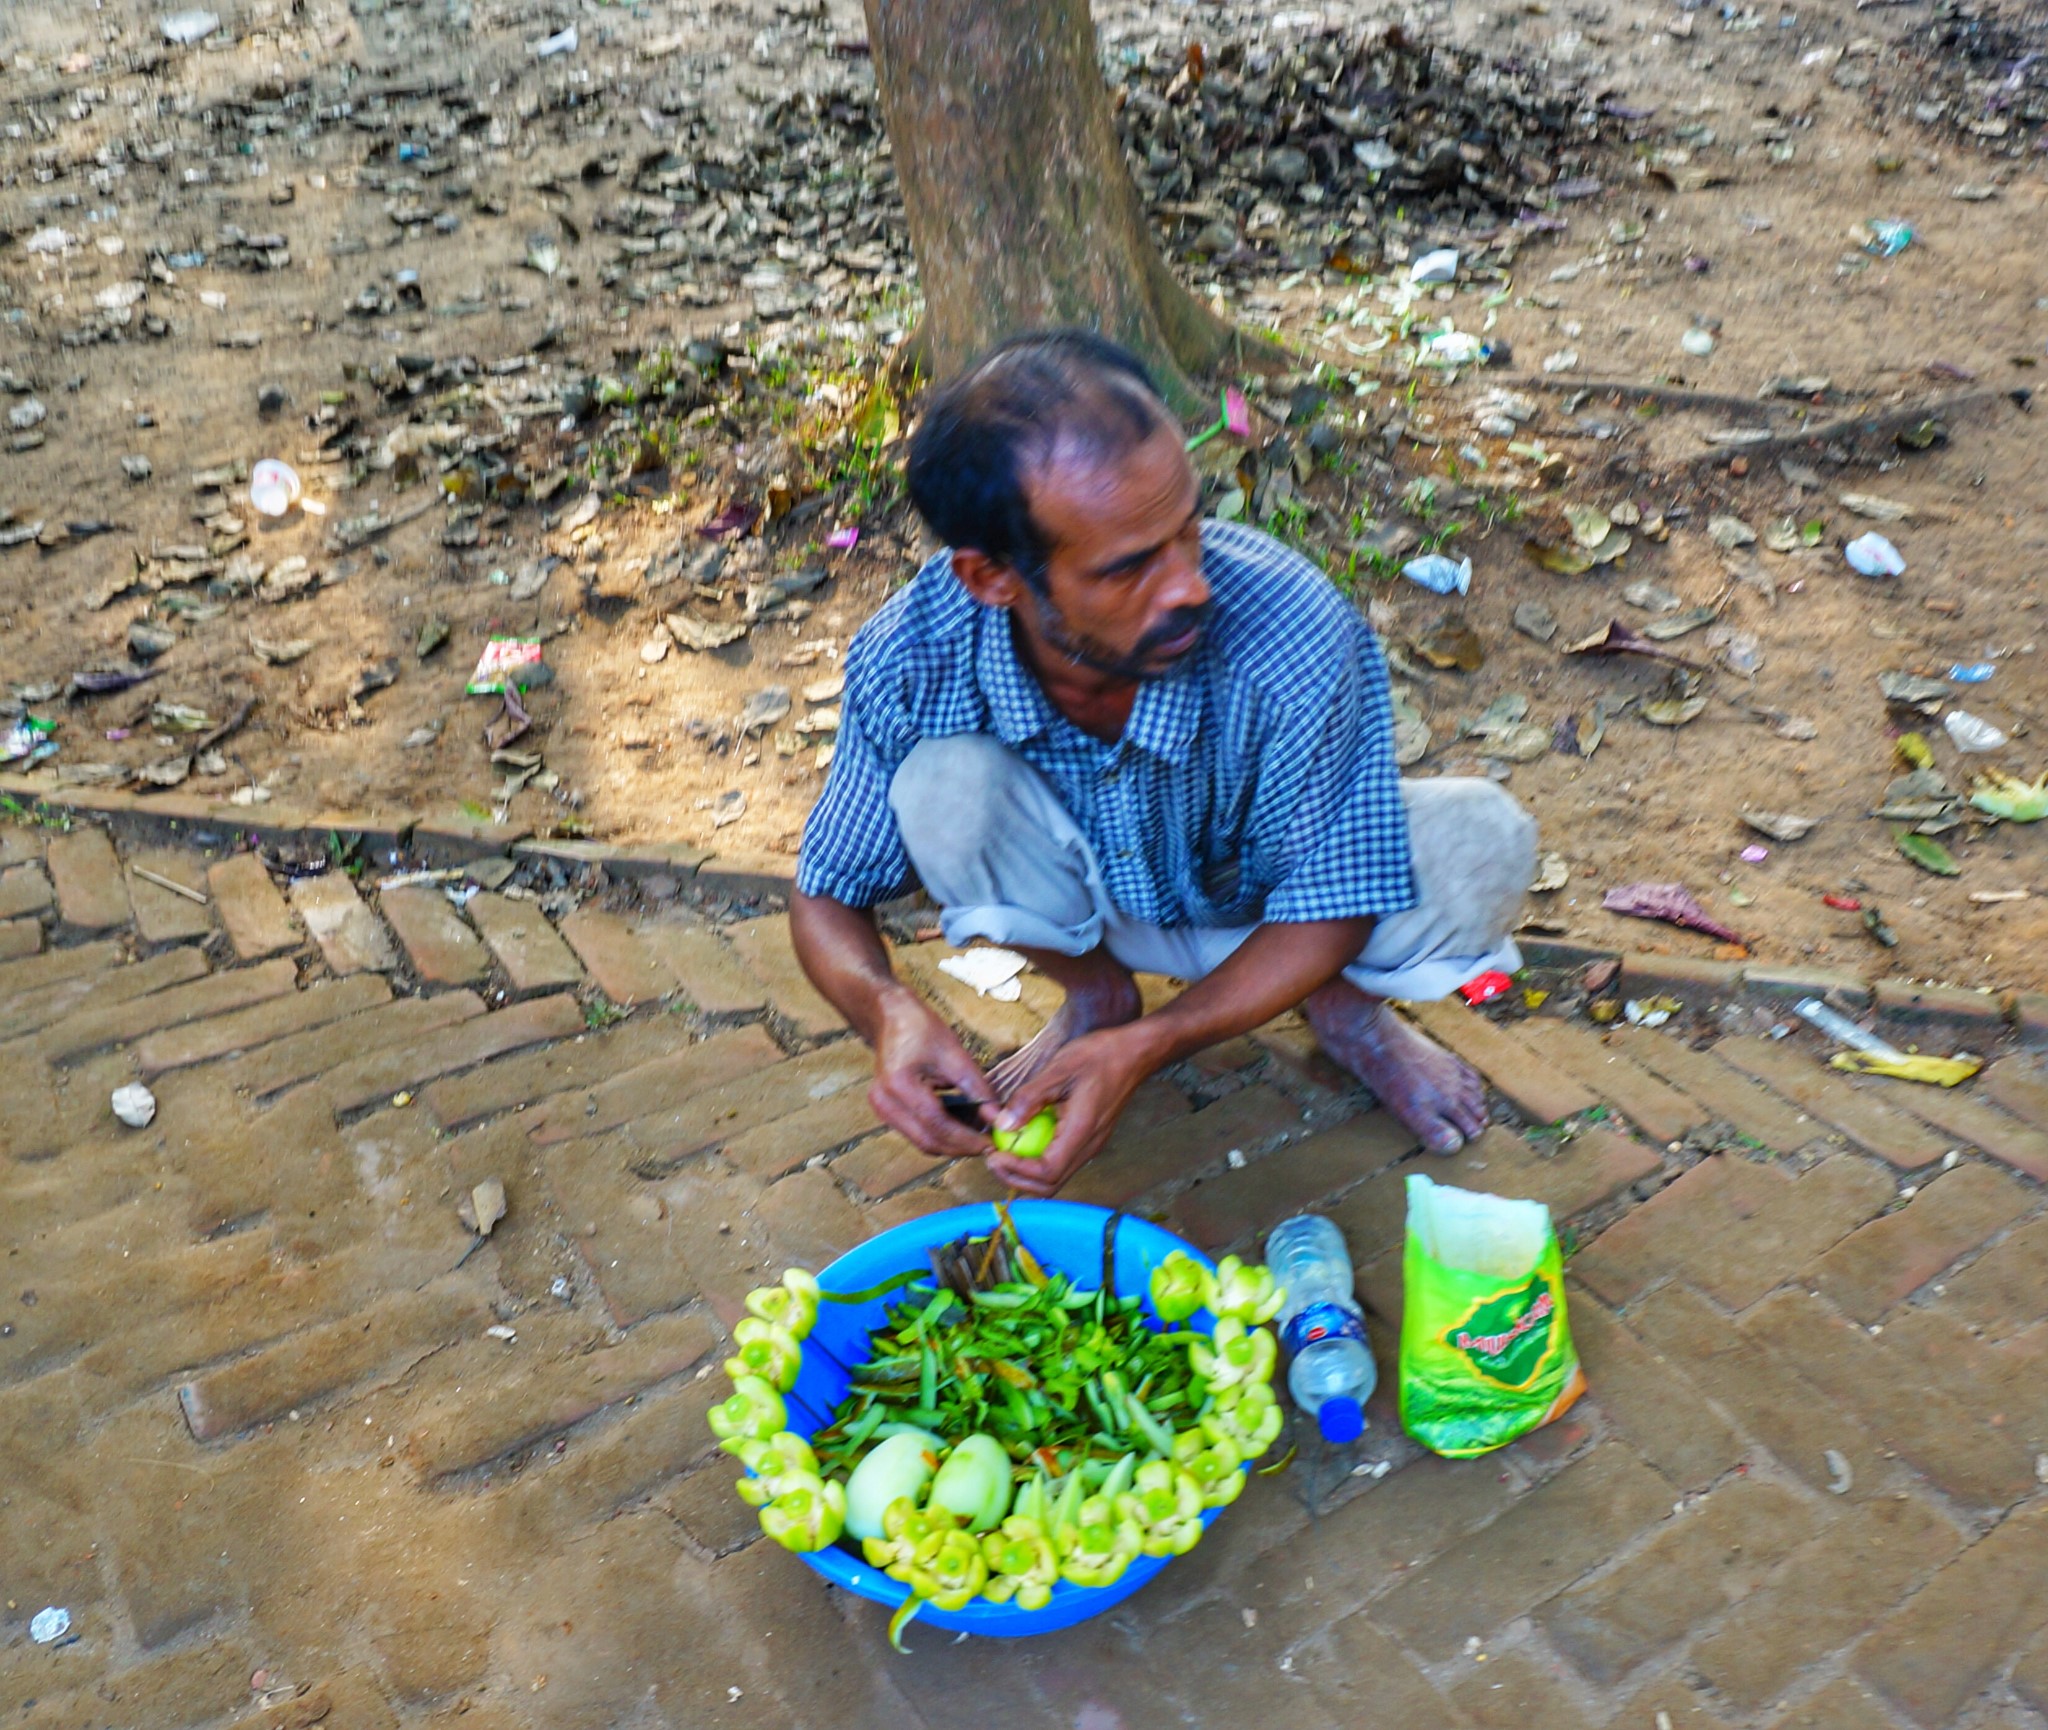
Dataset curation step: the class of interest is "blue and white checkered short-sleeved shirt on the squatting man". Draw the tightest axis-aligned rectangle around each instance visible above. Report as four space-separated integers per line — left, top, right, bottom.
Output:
797 522 1415 925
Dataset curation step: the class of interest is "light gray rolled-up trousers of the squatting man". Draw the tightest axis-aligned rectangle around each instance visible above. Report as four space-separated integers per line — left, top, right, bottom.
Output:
889 733 1536 1001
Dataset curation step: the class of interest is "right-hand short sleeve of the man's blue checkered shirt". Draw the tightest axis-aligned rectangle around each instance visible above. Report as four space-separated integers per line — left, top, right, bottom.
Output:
1262 620 1415 925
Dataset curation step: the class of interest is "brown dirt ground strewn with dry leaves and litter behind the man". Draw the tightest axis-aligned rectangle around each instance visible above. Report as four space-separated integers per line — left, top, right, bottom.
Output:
0 0 2048 987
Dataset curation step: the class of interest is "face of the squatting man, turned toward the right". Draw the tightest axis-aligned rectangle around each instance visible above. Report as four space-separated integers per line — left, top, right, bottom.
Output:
1020 426 1208 680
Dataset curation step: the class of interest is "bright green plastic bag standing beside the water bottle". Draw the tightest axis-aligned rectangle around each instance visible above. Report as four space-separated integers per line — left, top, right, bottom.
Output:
1401 1173 1585 1460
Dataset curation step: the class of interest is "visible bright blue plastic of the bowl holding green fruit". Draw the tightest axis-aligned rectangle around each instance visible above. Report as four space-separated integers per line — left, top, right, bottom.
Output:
770 1202 1223 1638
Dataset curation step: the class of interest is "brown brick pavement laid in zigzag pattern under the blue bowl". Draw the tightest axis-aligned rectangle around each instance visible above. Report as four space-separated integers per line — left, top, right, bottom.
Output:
0 827 2048 1730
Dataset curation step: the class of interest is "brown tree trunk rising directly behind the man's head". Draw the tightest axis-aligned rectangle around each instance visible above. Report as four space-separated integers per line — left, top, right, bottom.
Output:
864 0 1235 420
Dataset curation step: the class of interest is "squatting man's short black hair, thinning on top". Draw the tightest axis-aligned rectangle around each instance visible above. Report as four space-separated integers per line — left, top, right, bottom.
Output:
905 330 1176 594
